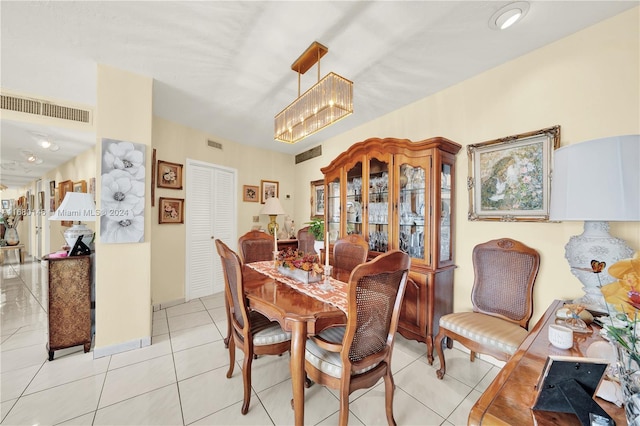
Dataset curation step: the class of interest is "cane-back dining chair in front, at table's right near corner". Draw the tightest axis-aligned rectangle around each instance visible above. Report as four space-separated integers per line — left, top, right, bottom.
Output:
305 250 411 426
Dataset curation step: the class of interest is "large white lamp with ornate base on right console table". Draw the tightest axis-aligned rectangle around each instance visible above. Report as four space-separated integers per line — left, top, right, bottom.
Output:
549 135 640 312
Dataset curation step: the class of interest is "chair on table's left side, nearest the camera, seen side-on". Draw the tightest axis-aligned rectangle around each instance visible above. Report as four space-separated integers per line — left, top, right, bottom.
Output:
216 240 291 414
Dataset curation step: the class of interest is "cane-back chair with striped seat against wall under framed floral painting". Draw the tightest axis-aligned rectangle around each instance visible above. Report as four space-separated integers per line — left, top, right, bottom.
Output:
435 238 540 379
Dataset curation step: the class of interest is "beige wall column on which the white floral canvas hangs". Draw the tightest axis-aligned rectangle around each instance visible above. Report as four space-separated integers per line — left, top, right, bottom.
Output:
94 65 153 357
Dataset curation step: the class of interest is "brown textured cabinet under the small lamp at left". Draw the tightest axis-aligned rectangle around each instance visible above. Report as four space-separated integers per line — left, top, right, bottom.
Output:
45 255 92 361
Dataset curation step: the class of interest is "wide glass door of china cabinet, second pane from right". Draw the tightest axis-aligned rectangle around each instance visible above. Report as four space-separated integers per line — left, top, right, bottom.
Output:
398 164 428 260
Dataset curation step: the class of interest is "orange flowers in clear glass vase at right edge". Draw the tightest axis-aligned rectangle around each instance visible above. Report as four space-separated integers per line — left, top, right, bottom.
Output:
592 252 640 424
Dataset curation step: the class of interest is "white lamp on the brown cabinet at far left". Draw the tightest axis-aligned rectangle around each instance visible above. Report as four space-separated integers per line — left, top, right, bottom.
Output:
49 192 97 248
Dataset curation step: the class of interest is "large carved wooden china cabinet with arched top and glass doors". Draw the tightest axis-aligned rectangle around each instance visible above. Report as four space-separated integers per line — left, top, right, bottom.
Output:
321 137 461 363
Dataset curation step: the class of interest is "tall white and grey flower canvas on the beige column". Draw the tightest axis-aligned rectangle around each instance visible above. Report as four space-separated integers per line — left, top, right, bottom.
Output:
99 139 146 243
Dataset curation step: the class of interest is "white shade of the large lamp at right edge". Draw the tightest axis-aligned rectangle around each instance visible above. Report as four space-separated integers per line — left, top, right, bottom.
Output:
549 135 640 222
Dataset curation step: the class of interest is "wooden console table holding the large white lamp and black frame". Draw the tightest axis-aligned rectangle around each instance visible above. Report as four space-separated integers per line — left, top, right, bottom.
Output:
469 300 627 426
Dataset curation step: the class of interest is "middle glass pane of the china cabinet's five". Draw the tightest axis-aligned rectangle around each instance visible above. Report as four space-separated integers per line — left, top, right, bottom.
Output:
367 158 392 253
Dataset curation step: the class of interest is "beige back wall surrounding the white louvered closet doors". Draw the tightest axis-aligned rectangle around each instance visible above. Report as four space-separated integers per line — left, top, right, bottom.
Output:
151 117 295 305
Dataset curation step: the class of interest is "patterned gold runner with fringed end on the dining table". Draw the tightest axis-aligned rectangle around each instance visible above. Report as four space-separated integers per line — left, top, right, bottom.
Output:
246 260 348 314
